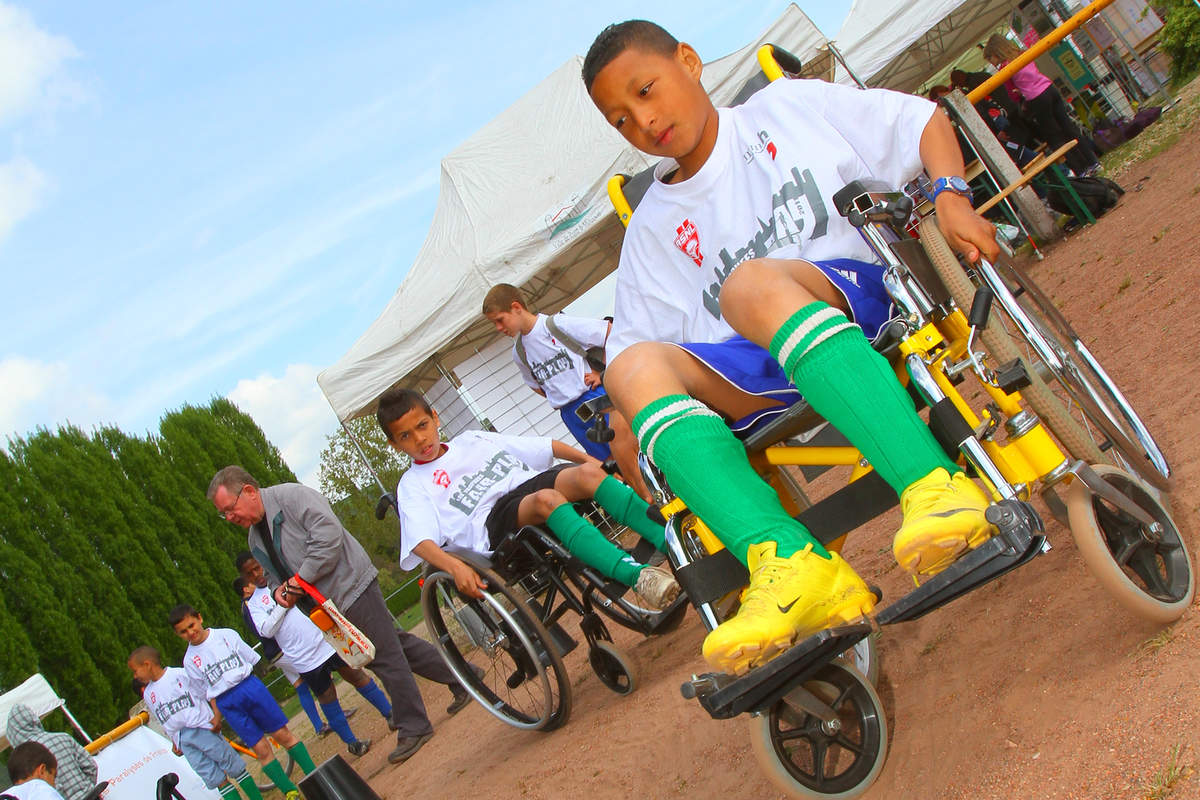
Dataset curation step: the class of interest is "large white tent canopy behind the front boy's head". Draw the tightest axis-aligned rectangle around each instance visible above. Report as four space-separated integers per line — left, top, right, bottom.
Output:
317 5 826 421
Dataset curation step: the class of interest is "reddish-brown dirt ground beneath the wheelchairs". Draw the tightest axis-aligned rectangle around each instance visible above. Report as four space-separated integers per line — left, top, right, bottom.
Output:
290 89 1200 800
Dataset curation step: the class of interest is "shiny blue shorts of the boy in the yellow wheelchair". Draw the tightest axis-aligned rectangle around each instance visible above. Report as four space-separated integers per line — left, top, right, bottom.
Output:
676 258 893 439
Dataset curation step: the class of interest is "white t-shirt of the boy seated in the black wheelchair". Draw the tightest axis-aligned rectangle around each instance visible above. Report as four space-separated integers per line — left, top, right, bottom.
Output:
396 431 554 570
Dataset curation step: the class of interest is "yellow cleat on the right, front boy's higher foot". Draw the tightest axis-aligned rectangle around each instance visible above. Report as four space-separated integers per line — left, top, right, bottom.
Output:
892 467 996 578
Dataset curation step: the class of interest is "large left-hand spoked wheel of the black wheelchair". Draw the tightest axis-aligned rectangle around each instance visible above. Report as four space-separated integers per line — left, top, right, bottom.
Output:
421 570 571 730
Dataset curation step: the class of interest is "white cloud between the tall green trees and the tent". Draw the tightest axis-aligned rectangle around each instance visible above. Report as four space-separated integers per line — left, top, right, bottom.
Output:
229 363 337 489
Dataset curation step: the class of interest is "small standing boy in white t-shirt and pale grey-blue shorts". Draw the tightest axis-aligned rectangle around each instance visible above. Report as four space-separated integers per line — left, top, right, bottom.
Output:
127 645 263 800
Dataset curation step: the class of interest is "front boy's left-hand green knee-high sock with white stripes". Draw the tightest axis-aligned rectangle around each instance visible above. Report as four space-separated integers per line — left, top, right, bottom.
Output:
632 395 829 564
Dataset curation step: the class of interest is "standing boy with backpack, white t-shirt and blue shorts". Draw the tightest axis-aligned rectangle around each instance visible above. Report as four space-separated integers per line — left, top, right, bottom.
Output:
484 283 649 499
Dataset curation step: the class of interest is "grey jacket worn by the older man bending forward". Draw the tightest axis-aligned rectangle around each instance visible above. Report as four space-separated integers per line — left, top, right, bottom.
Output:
247 483 379 612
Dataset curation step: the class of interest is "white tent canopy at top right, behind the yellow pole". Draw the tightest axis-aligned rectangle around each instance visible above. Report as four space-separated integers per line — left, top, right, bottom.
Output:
834 0 1016 92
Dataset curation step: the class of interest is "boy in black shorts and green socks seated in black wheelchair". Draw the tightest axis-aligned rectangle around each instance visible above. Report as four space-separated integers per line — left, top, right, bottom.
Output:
376 387 679 608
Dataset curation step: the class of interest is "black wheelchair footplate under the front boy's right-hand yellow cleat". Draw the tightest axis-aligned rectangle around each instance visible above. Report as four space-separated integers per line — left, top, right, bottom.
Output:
875 500 1046 625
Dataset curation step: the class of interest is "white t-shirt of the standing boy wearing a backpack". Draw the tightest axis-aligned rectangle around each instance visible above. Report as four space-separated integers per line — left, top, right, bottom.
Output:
512 314 608 408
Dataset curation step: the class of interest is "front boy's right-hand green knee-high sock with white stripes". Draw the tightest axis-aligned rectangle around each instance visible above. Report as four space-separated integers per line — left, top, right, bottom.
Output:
768 302 961 494
